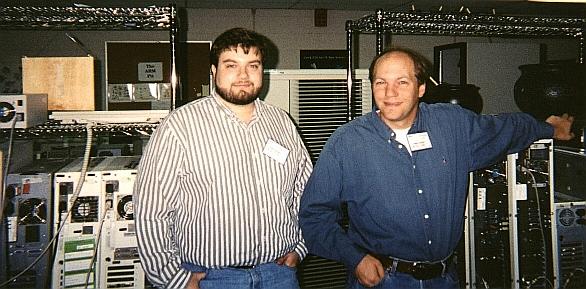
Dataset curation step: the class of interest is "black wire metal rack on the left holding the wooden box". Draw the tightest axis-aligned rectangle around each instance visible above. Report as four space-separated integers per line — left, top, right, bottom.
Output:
0 5 179 138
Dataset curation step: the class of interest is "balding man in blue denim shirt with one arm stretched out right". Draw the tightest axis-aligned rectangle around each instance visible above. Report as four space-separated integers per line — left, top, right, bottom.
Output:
299 48 573 289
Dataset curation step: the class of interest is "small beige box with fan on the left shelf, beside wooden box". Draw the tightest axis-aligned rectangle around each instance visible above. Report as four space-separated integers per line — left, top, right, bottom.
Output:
0 94 47 129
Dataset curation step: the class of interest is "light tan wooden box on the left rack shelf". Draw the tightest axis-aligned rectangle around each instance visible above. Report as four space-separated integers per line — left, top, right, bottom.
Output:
22 56 95 111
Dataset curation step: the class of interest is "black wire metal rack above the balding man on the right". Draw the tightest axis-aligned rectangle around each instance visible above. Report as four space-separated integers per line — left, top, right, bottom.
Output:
346 9 586 120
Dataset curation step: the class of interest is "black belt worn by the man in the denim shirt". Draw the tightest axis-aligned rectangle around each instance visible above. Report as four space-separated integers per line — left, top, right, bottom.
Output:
373 255 452 280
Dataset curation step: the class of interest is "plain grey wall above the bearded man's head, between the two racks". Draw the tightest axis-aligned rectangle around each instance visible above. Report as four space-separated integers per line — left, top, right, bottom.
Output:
180 9 375 69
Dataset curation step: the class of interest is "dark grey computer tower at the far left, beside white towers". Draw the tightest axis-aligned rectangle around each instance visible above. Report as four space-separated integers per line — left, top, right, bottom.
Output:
0 160 68 289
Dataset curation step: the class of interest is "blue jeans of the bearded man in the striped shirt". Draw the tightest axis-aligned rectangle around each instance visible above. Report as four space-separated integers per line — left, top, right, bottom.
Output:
184 262 299 289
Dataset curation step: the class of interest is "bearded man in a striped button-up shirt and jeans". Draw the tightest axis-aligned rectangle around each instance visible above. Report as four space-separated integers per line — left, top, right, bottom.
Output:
133 28 312 289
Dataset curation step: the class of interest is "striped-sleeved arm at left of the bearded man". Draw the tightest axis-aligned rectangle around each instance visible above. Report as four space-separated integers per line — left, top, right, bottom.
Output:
133 123 190 288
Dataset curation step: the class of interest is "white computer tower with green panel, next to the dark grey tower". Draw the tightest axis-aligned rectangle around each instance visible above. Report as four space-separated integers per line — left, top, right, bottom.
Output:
52 157 106 288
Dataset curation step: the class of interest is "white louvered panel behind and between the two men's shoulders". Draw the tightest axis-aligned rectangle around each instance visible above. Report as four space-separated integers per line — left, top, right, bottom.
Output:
291 75 372 163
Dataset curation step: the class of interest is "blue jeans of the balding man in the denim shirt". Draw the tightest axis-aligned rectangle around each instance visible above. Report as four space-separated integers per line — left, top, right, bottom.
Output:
348 264 460 289
